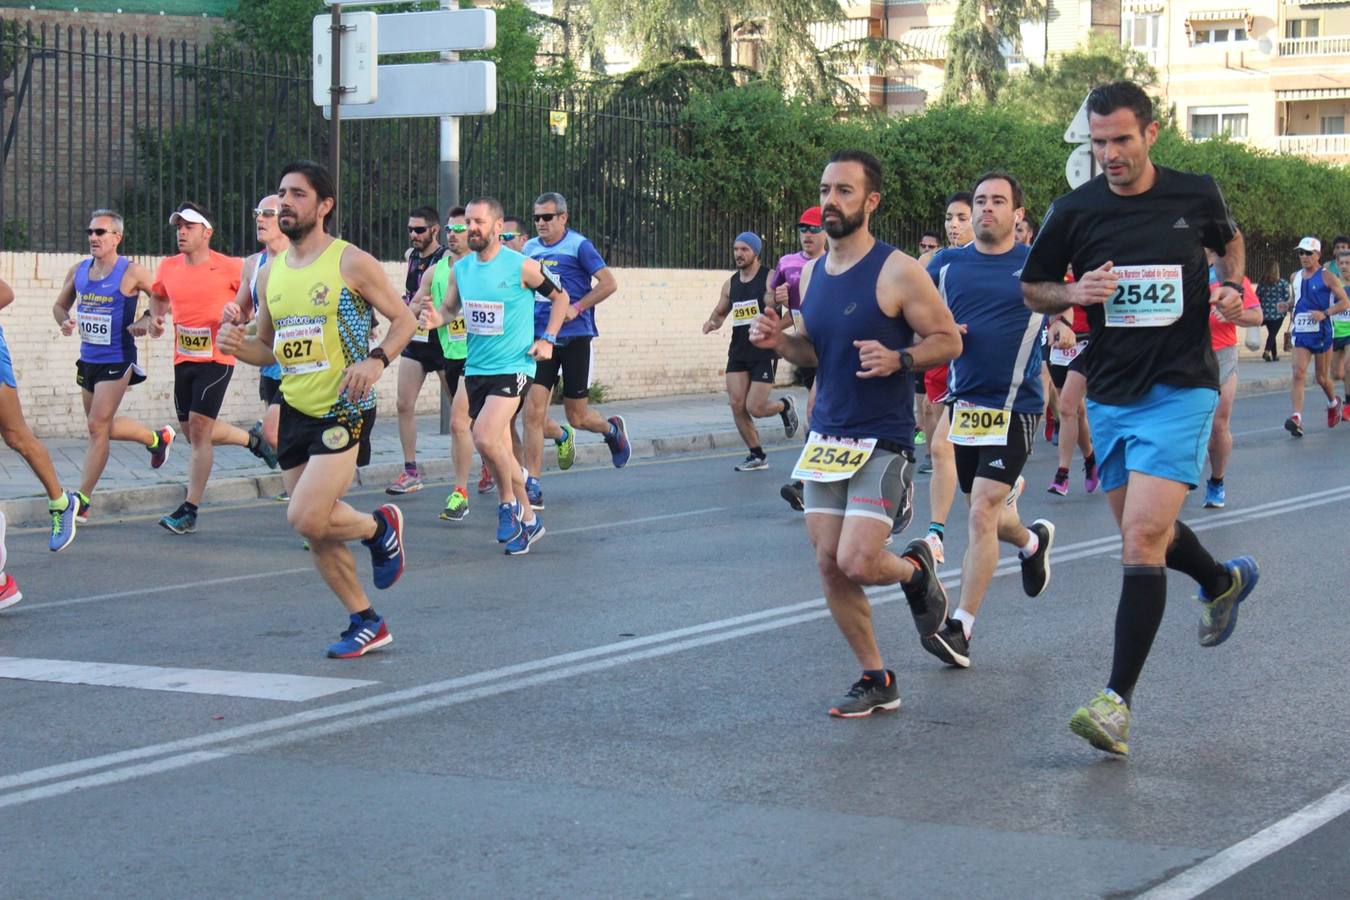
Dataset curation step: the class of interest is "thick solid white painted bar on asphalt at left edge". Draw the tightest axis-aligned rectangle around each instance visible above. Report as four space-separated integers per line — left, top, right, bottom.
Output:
0 656 379 703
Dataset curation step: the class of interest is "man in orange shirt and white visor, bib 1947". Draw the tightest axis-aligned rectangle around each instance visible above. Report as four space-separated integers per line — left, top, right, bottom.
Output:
151 202 277 534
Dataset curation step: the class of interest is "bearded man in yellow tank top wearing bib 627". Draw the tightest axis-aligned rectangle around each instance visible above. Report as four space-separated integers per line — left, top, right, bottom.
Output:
217 162 417 658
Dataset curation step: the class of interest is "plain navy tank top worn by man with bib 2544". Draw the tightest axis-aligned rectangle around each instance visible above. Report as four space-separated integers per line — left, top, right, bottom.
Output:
802 240 914 451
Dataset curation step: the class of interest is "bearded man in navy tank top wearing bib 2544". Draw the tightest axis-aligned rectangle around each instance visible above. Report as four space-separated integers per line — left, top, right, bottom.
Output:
751 150 961 718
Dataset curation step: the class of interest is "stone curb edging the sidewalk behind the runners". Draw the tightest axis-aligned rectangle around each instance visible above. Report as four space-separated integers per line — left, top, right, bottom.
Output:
0 429 801 526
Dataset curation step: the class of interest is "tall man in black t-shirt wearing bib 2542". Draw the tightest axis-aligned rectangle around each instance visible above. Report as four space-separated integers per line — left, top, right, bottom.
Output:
1022 81 1258 754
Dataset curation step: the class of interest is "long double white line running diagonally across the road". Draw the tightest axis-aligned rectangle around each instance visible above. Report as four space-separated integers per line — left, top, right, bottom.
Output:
0 484 1350 825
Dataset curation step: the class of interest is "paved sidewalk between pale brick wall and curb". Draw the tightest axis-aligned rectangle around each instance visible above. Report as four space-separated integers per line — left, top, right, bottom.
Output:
0 359 1296 525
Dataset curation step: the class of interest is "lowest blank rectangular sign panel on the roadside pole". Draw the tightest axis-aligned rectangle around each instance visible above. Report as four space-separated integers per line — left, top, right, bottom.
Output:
324 59 497 119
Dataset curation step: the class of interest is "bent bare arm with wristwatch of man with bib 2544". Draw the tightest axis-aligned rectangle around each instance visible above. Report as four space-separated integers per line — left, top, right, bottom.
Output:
880 252 961 375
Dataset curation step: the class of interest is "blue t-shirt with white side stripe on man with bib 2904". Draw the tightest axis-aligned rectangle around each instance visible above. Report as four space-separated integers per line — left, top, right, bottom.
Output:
927 243 1045 413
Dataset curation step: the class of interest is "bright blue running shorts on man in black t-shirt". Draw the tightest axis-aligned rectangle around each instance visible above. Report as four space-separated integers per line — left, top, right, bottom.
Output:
1088 385 1219 491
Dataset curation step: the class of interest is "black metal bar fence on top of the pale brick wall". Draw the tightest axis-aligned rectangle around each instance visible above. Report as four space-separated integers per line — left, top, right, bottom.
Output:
0 20 896 269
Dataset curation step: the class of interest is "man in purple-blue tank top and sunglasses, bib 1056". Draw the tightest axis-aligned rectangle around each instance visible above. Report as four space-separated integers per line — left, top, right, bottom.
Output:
51 209 174 522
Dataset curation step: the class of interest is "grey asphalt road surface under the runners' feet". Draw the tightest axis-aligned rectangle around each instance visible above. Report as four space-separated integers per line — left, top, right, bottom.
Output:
0 395 1350 897
